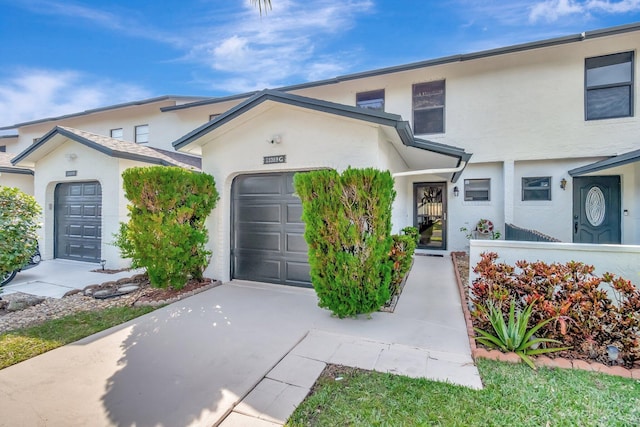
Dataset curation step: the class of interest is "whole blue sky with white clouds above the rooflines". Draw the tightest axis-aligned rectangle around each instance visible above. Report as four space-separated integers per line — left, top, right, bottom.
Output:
0 0 640 126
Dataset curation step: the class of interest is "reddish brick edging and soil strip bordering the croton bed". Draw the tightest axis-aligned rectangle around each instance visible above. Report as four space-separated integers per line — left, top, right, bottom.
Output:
452 252 640 379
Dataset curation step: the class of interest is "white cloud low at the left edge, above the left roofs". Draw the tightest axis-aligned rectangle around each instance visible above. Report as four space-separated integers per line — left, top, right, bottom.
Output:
0 69 150 126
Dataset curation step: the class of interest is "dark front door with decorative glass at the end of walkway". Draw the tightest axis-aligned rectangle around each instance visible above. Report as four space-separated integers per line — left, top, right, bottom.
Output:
413 182 447 249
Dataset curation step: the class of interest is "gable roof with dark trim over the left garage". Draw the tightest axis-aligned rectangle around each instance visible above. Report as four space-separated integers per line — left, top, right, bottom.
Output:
12 126 200 170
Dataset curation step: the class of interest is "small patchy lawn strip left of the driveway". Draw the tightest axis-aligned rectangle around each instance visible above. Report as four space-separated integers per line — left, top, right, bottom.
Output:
0 307 155 369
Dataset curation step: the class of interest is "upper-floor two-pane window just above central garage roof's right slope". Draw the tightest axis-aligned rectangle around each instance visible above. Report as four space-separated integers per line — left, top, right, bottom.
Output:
412 80 445 135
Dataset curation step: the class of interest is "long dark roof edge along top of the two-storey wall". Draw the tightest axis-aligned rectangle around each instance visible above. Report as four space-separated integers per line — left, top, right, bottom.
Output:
160 23 640 112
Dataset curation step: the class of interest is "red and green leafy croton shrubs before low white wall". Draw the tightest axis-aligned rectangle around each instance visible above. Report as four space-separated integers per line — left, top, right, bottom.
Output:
471 253 640 366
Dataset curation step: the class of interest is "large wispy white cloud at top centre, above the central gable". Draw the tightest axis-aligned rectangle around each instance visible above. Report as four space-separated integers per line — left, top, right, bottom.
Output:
183 0 373 92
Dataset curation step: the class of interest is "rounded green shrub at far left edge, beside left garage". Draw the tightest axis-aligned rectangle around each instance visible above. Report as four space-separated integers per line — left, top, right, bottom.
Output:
0 186 40 276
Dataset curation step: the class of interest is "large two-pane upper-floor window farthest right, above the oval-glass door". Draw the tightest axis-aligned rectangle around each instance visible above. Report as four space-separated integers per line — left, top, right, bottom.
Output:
584 52 633 120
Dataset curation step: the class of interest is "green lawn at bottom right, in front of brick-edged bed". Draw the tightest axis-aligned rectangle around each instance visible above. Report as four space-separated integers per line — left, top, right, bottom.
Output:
288 359 640 427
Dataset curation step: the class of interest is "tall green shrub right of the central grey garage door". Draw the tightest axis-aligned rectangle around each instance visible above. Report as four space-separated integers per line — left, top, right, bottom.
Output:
294 168 395 317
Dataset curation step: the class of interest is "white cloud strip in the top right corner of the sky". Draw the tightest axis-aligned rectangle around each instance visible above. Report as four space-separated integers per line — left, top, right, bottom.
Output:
529 0 640 22
